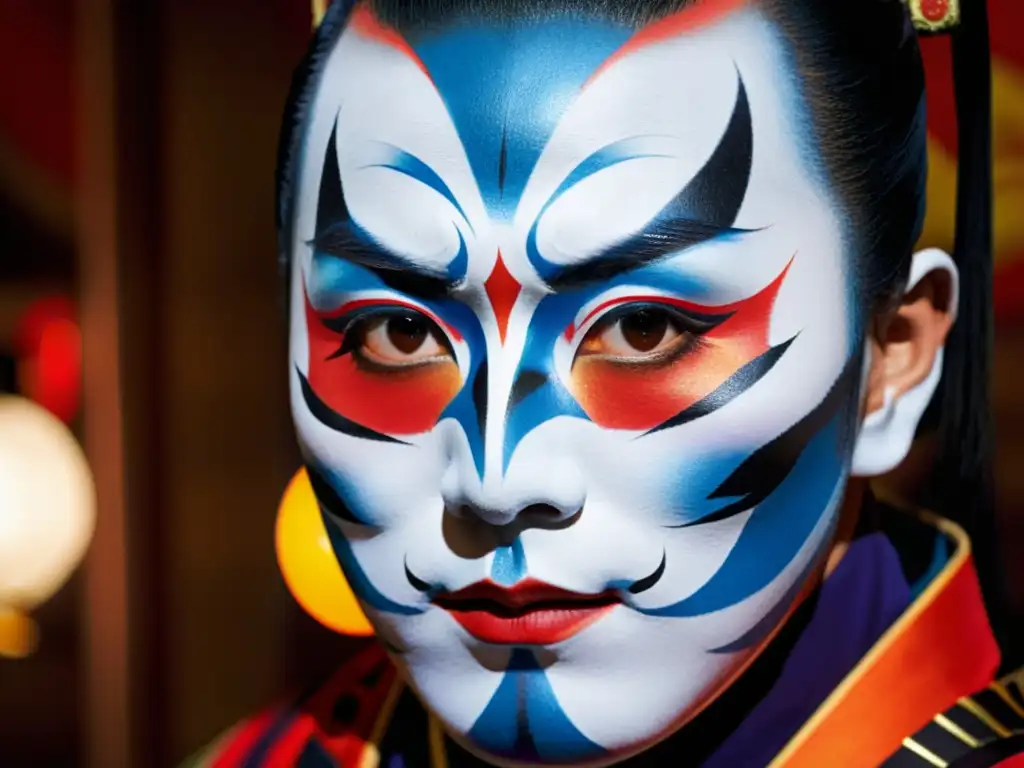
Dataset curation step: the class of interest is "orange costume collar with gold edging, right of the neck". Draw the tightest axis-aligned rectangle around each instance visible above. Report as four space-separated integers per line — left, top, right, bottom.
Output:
769 512 999 768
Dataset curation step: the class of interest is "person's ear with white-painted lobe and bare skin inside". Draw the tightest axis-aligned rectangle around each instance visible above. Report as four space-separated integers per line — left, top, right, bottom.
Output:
851 248 959 477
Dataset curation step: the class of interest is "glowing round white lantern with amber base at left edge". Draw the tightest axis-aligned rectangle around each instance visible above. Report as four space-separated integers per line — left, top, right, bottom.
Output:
0 395 96 656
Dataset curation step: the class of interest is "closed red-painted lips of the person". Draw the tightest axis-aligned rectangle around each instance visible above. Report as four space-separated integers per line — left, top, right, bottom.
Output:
434 579 621 645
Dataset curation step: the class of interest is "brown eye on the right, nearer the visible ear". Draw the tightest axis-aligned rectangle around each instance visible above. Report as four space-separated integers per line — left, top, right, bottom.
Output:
580 307 692 361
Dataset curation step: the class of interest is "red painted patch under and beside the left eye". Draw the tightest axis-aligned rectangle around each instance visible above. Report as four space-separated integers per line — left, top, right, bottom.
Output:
306 290 462 435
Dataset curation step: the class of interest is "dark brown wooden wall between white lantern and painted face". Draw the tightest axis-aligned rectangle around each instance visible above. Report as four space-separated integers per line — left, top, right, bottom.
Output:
78 0 348 768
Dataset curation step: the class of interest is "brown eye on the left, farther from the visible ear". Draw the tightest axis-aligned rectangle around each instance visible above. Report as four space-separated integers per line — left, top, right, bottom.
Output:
348 312 450 367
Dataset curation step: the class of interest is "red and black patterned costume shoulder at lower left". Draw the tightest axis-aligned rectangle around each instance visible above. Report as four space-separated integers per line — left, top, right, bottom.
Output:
182 642 404 768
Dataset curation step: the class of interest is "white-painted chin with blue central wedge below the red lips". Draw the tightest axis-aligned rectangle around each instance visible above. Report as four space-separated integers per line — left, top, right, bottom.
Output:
385 606 759 766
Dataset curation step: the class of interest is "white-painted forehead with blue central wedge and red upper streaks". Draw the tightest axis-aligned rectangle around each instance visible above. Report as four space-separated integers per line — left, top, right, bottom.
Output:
296 0 835 286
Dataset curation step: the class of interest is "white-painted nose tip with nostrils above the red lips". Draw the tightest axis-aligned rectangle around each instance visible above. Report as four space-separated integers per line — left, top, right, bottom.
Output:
441 455 587 528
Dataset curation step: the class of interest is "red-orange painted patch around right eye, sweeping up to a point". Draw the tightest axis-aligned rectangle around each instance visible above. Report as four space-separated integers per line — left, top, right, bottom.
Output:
572 265 790 430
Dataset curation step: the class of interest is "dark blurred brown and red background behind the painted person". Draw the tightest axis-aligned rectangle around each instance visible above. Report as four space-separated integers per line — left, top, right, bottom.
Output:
0 0 1024 768
